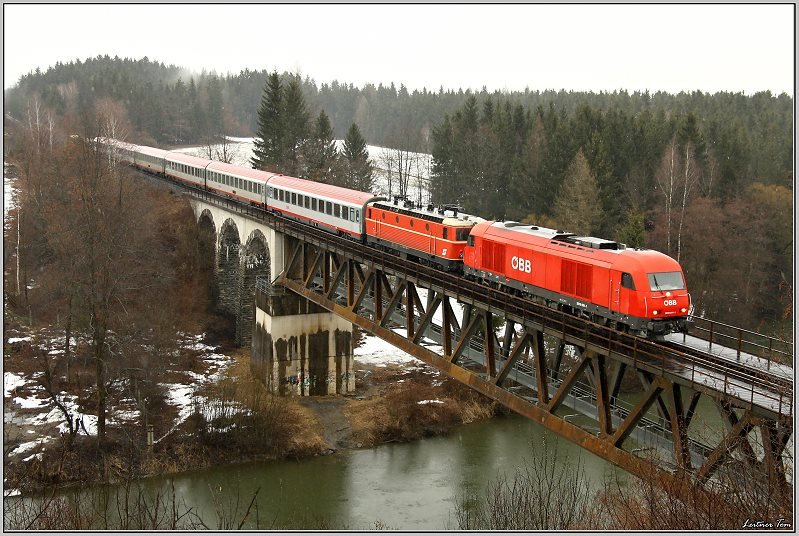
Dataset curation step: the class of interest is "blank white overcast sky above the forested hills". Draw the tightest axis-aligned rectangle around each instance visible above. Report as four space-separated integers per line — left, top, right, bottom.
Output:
3 4 795 95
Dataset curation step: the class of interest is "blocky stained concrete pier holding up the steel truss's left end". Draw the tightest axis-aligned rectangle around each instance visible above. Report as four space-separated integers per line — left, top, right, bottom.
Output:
252 284 355 396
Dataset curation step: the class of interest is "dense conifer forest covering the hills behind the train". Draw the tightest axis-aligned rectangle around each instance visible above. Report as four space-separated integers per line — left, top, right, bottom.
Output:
4 56 794 338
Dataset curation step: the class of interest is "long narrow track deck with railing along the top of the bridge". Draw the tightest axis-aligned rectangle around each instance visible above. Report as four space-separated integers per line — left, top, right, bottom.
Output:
142 172 793 417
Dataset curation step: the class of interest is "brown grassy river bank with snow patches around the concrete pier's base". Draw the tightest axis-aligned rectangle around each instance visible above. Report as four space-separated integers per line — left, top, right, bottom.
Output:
4 320 497 494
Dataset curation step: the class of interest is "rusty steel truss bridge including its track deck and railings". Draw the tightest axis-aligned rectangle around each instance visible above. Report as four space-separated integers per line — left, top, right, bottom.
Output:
148 173 793 506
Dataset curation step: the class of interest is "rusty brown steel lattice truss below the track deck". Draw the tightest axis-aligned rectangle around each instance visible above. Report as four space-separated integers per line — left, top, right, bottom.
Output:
276 238 792 500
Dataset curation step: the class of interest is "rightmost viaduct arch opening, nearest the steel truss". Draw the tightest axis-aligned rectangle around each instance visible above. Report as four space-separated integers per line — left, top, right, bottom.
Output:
241 229 272 346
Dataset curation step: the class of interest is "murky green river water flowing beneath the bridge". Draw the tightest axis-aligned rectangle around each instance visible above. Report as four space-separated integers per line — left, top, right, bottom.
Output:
18 416 627 530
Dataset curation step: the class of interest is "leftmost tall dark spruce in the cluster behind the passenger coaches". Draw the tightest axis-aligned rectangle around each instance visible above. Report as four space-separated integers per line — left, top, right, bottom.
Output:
250 71 285 172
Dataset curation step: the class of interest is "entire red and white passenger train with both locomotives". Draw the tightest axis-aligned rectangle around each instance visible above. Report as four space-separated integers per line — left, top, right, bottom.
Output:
98 138 691 338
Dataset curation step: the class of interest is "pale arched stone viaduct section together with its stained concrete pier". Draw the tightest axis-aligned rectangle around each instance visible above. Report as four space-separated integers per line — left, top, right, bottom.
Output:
191 199 355 395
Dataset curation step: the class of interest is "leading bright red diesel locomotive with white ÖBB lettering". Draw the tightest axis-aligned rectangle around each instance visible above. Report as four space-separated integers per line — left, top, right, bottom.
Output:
464 222 691 335
